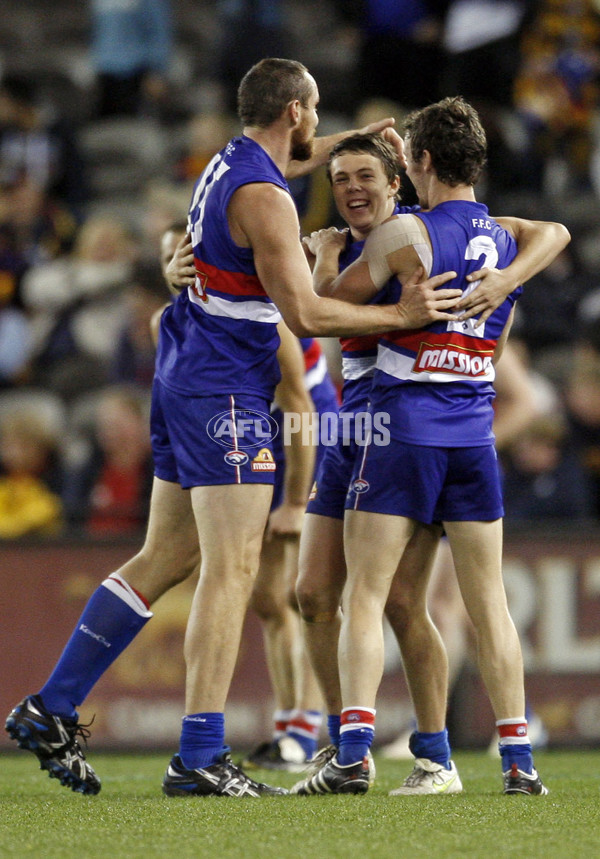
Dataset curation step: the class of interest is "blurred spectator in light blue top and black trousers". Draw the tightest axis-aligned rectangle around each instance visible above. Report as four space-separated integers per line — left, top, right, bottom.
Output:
91 0 173 117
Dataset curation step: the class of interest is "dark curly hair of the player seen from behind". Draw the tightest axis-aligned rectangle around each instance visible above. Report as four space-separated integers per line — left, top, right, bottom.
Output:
404 96 487 188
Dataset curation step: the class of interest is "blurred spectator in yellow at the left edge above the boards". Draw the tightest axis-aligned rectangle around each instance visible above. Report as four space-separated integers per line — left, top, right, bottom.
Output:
0 407 63 540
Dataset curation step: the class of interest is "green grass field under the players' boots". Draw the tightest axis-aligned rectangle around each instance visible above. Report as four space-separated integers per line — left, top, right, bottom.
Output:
0 751 600 859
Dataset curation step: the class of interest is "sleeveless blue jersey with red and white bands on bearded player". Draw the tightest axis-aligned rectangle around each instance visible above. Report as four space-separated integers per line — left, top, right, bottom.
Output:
156 136 289 400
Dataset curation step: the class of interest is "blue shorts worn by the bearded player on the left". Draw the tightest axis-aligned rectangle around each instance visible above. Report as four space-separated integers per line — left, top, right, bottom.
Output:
150 379 279 489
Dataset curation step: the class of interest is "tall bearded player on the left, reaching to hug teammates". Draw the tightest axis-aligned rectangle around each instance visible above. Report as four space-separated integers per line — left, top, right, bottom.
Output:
6 59 461 797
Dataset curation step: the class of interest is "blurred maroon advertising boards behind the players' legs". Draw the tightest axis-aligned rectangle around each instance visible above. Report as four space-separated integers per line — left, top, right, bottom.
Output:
0 531 600 749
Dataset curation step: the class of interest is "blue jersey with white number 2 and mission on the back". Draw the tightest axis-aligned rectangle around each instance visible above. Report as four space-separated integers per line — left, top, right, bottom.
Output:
371 201 521 447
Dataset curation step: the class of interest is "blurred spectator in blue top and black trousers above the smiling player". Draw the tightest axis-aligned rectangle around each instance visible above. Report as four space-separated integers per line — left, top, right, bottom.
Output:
336 0 447 115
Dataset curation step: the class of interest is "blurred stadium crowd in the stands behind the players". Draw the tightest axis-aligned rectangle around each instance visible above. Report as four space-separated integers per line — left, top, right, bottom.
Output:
0 0 600 539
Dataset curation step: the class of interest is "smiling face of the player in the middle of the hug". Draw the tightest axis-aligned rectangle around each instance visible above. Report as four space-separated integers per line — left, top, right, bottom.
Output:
330 152 400 240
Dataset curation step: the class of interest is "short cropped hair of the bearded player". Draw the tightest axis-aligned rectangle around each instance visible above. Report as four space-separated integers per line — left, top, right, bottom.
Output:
238 57 313 128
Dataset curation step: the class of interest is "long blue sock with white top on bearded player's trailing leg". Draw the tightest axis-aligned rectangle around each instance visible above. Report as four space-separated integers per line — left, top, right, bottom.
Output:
38 575 152 719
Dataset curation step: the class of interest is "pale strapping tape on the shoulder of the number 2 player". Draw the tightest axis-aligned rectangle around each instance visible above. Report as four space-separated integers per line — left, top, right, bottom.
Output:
362 215 432 287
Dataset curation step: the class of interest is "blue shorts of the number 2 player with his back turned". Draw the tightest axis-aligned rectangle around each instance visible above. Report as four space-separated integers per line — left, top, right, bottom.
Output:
346 440 504 524
